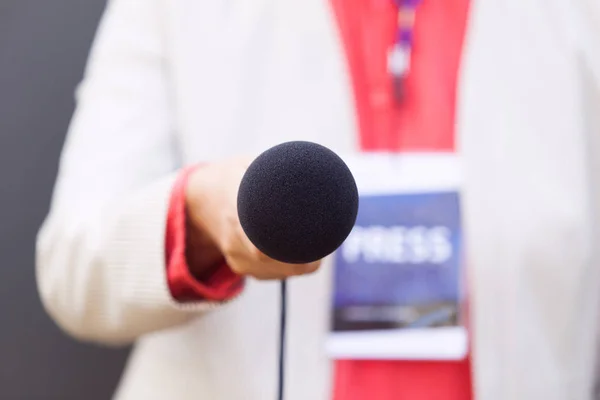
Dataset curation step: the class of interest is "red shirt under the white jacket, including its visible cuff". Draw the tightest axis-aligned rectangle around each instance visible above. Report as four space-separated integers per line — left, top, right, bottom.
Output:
166 0 472 400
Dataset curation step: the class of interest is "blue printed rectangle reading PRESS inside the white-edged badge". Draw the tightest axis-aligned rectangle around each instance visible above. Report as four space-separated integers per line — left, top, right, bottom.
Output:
333 192 462 331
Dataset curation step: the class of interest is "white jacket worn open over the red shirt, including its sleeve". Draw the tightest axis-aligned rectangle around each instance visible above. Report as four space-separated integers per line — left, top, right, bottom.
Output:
37 0 600 400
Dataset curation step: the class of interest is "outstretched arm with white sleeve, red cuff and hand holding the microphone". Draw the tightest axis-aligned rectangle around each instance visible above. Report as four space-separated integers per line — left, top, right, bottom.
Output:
36 0 320 344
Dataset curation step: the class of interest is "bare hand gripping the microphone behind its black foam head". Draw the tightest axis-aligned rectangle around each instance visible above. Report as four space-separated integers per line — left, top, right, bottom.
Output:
186 158 320 280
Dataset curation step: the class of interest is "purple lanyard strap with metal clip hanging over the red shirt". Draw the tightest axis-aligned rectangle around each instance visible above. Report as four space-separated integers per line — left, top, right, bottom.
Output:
387 0 421 103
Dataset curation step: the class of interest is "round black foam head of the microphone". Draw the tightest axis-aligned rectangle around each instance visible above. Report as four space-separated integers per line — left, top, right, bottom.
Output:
237 141 358 264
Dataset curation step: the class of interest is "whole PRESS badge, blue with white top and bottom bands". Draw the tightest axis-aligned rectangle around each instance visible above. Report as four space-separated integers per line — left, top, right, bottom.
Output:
327 153 468 360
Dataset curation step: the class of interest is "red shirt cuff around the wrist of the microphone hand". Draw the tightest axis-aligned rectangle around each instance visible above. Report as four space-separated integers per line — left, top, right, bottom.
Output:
165 167 244 302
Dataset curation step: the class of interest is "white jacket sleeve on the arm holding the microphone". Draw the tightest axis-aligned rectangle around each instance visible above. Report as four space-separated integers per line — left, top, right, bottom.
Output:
36 0 212 344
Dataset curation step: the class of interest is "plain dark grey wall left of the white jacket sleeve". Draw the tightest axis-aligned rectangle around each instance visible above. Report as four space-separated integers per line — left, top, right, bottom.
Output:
0 0 127 400
